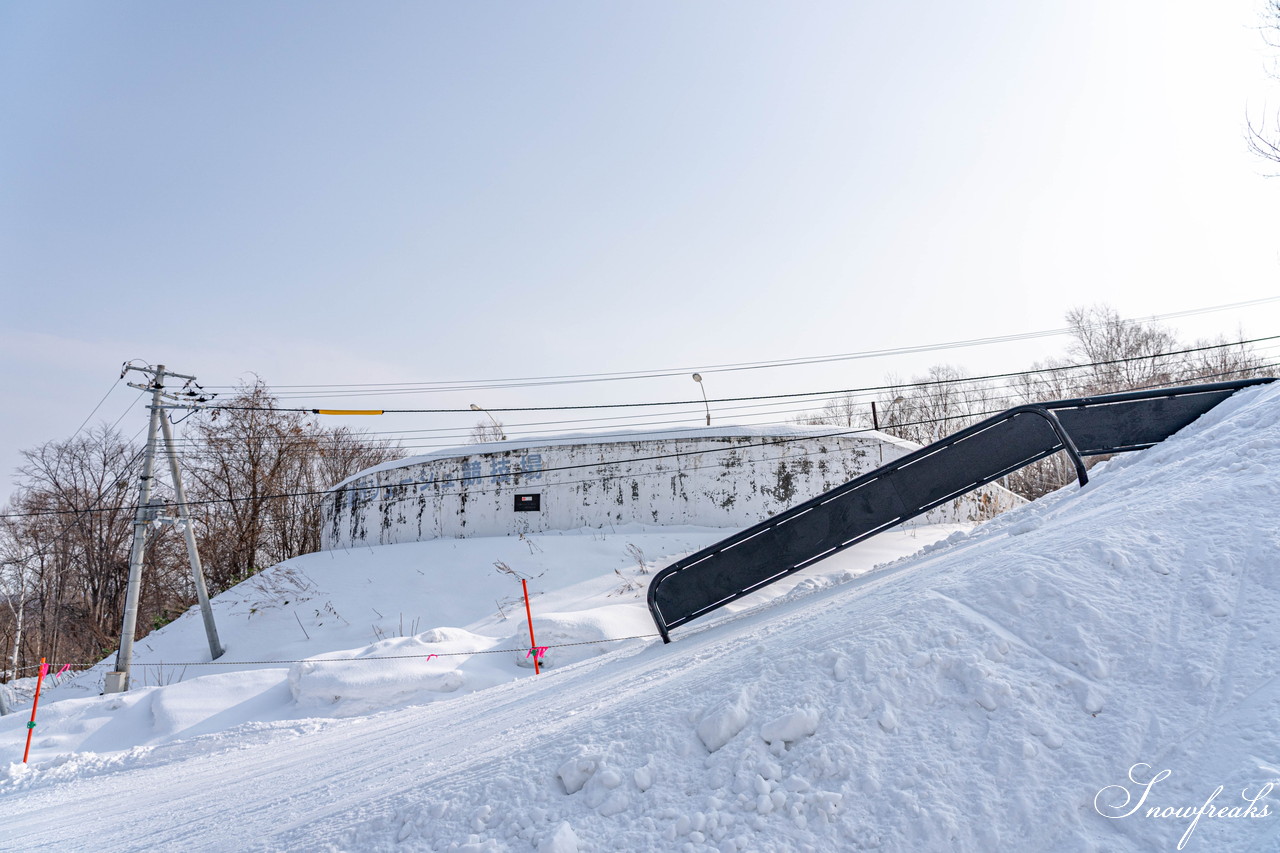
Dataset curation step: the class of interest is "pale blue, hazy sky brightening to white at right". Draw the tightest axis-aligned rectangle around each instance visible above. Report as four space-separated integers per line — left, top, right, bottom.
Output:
0 0 1280 489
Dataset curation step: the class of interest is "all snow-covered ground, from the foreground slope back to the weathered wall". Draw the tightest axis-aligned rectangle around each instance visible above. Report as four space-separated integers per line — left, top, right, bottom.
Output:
0 387 1280 853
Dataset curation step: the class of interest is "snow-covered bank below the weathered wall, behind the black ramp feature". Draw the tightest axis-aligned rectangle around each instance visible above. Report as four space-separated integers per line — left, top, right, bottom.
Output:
0 517 968 762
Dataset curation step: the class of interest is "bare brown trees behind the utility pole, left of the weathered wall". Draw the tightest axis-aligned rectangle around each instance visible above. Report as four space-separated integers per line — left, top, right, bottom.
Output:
0 379 402 675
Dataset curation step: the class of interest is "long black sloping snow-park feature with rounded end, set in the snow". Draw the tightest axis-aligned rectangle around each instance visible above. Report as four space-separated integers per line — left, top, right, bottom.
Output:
649 378 1275 643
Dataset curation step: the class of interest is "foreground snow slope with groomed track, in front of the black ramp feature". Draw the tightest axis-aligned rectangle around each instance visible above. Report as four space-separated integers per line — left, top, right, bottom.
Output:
0 387 1280 852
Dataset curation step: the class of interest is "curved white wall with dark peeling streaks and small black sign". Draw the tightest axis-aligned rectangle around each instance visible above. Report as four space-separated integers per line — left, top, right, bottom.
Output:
324 430 1020 548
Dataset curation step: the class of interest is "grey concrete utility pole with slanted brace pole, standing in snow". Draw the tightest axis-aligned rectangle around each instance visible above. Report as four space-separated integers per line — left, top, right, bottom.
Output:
105 364 223 693
